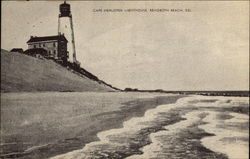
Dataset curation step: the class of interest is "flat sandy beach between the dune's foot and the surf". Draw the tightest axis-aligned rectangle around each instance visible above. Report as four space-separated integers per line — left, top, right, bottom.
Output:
1 92 184 158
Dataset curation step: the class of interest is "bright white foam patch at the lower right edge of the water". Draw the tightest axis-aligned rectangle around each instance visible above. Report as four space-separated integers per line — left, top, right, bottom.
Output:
199 112 249 159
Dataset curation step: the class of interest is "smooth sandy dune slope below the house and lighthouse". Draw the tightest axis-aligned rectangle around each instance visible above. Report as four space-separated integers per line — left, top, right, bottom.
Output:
1 49 114 92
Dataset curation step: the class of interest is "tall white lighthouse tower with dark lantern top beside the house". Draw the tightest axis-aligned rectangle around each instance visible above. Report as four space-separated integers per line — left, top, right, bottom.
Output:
58 1 80 65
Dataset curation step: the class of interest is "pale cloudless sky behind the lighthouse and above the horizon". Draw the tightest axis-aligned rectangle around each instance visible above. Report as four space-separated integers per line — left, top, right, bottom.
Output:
1 1 249 90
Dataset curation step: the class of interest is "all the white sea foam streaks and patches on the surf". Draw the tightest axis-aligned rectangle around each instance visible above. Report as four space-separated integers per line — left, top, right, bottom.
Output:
50 96 249 159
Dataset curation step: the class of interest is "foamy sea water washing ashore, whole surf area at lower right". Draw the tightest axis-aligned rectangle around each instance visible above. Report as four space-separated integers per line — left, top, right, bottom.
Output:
51 95 249 159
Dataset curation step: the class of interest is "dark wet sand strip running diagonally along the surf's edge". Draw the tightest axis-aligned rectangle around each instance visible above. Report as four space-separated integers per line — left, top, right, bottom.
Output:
1 94 185 159
